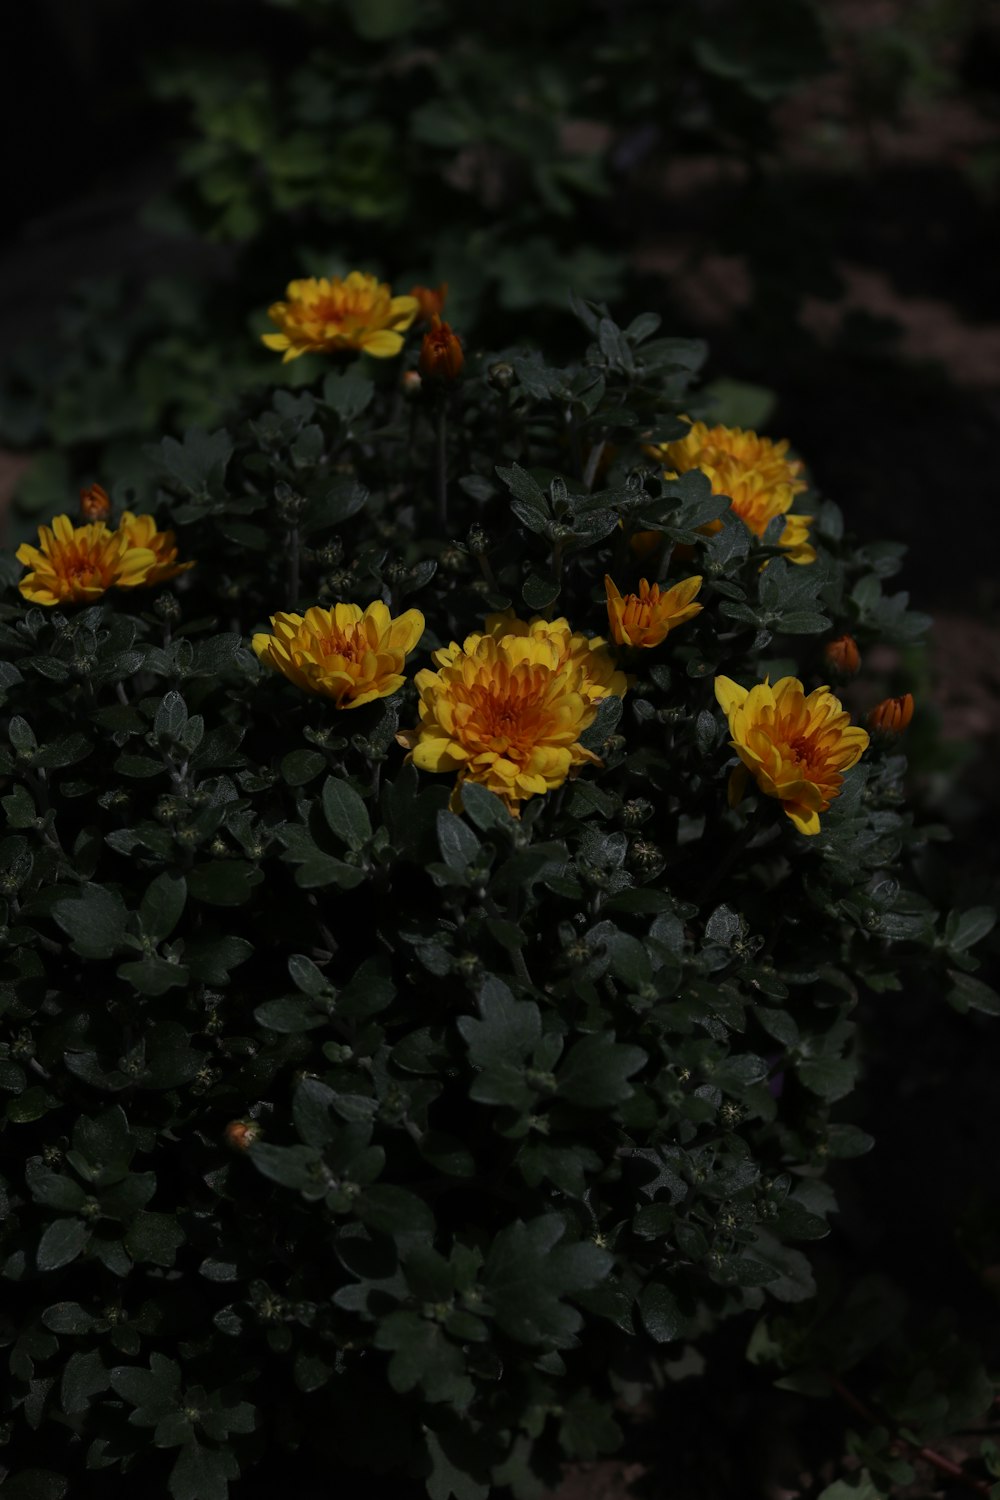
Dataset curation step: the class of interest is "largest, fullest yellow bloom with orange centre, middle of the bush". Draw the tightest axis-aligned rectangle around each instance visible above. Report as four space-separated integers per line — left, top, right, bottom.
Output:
397 635 601 816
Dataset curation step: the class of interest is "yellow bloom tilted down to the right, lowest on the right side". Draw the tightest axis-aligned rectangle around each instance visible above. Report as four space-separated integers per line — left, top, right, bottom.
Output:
715 677 868 834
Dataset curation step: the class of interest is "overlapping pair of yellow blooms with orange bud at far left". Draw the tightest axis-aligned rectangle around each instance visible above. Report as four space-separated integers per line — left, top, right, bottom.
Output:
16 485 195 605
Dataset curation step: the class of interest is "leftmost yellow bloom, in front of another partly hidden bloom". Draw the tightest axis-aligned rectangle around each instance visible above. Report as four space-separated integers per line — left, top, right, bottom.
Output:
16 516 156 605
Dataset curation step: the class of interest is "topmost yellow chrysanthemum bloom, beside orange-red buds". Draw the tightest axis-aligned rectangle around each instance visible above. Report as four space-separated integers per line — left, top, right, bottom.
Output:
262 272 420 363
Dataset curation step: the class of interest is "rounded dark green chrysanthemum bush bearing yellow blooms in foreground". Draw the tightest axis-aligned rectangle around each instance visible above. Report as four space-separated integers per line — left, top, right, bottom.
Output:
0 283 1000 1500
